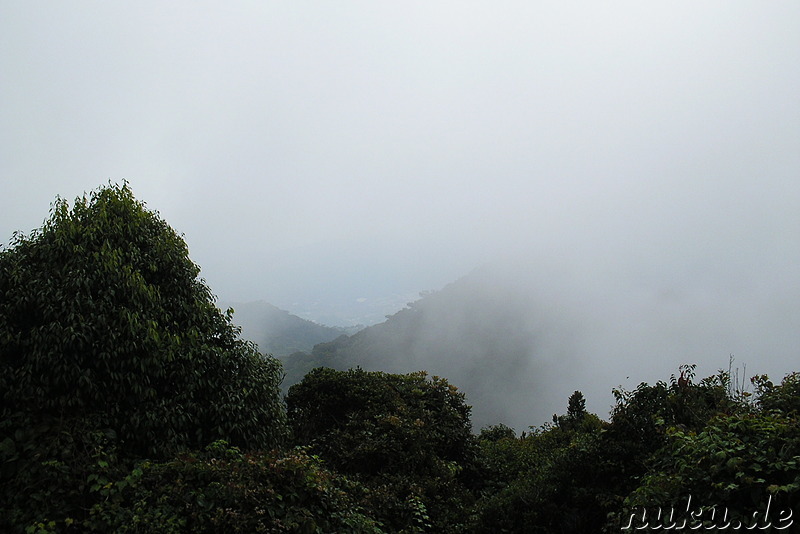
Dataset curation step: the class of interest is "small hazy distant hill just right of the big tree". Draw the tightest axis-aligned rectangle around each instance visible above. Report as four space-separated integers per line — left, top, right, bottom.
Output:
225 301 358 359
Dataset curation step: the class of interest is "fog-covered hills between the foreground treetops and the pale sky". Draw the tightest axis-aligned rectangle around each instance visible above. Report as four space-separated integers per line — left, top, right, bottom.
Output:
227 261 797 431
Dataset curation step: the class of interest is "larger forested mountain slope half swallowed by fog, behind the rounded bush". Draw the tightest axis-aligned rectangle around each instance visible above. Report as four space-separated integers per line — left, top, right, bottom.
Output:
285 268 571 429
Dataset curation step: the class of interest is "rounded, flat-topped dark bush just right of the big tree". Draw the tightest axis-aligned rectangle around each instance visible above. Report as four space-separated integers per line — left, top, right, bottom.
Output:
286 368 475 532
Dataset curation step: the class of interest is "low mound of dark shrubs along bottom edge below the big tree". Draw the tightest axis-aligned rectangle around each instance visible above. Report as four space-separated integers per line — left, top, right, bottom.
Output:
81 442 381 534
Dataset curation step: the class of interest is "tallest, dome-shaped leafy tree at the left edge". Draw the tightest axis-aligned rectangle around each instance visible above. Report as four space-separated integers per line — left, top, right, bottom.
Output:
0 184 286 532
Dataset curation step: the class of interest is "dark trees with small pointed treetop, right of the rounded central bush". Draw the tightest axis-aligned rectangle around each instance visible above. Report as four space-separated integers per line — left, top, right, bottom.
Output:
471 366 752 533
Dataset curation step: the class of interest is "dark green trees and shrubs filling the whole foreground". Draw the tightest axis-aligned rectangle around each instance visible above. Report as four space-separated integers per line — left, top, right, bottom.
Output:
0 185 800 534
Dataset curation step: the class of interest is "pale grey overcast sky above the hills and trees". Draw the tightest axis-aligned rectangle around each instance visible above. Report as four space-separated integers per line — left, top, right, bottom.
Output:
0 0 800 390
